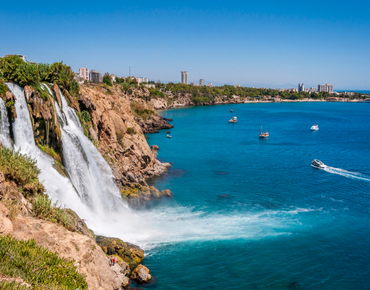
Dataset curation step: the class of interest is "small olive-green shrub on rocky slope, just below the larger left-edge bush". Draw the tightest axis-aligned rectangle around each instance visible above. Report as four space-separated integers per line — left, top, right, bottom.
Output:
31 195 71 227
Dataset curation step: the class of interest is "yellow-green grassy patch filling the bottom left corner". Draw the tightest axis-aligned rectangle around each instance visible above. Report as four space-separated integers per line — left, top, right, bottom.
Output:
0 236 87 289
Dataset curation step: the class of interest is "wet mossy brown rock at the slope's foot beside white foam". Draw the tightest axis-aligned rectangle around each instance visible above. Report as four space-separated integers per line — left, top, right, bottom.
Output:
96 236 144 266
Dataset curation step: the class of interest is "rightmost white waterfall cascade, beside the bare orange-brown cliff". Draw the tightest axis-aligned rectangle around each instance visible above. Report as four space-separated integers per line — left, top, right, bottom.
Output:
44 85 127 216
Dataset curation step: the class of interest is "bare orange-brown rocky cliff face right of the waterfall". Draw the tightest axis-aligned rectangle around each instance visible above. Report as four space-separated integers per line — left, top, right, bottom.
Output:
79 85 173 198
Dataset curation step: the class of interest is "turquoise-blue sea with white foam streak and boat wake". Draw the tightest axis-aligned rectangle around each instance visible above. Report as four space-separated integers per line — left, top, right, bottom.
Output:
141 103 370 289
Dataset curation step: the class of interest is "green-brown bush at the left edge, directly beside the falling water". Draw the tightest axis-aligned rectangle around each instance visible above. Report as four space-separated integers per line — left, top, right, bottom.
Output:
0 147 44 197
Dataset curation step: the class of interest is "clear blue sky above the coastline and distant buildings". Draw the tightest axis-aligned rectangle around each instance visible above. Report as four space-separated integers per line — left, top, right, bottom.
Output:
0 0 370 90
